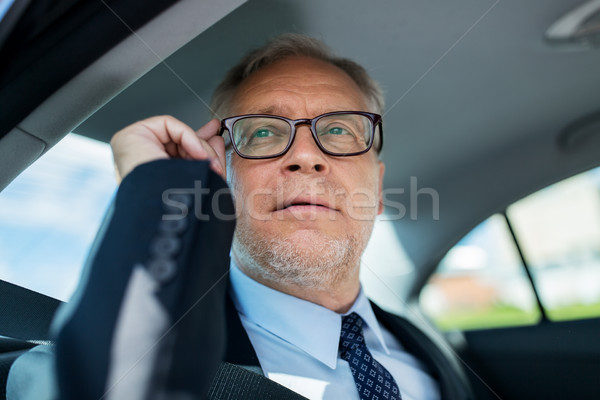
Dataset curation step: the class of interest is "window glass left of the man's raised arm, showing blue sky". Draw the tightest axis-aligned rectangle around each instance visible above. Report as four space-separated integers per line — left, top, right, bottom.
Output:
0 134 116 300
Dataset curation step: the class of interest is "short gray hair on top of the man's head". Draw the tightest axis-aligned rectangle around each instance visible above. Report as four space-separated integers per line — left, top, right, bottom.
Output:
211 33 384 118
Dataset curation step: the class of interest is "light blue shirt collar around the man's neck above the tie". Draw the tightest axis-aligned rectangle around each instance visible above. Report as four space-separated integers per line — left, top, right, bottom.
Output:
229 258 389 369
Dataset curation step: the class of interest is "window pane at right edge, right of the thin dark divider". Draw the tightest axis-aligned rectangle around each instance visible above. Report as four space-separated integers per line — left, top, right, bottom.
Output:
507 168 600 320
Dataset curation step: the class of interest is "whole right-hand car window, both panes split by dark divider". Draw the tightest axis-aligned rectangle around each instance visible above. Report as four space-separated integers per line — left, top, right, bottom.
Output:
419 168 600 330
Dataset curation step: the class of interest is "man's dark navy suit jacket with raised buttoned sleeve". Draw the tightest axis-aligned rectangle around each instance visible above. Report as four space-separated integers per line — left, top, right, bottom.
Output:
5 160 472 400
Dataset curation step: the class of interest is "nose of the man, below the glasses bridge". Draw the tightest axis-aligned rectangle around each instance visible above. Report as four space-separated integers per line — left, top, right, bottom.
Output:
283 125 330 174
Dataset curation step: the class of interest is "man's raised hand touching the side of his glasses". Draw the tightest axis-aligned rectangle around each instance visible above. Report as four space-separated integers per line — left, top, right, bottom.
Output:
110 116 226 179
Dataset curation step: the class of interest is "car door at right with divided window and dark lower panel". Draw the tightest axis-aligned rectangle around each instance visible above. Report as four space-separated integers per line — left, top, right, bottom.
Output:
420 168 600 399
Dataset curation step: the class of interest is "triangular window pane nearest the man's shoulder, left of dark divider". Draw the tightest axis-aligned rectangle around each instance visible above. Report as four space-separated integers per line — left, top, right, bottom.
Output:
419 214 540 330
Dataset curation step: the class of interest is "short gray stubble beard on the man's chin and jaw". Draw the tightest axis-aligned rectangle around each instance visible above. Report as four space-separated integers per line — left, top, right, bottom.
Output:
233 226 370 290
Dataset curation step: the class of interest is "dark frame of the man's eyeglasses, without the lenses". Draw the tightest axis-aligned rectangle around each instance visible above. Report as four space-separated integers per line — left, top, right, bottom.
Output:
219 111 383 160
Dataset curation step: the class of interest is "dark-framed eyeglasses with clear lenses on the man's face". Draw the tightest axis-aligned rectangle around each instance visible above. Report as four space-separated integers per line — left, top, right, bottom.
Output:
220 111 383 159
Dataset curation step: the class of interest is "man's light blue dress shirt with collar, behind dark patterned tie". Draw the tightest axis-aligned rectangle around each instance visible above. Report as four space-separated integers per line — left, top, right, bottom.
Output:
230 261 440 400
